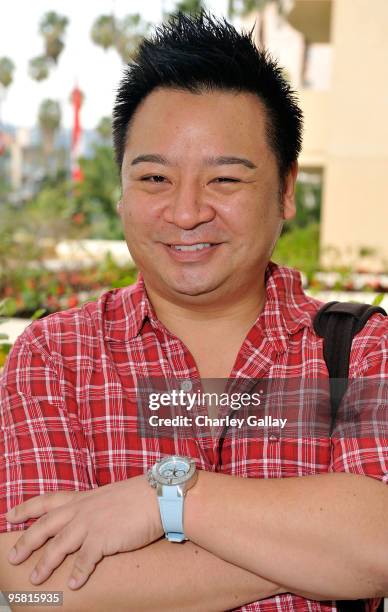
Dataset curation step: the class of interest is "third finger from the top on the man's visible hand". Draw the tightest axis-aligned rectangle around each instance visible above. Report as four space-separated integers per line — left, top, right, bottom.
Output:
30 522 87 584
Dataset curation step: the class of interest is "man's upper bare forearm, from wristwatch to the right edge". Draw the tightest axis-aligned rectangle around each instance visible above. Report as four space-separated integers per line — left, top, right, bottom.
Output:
184 472 388 599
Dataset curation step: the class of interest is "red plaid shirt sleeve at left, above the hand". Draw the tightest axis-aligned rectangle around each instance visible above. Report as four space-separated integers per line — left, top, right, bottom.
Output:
0 322 94 533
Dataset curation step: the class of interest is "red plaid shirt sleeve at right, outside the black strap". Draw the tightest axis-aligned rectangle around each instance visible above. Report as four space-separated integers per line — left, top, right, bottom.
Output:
329 315 388 483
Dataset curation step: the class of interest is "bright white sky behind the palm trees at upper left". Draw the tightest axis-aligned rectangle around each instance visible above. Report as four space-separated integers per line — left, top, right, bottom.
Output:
0 0 227 128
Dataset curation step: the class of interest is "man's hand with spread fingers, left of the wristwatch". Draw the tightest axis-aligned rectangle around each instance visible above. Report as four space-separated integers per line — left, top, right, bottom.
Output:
6 476 164 589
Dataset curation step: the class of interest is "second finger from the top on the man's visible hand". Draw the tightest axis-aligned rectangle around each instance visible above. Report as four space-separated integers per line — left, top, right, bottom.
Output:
8 505 75 564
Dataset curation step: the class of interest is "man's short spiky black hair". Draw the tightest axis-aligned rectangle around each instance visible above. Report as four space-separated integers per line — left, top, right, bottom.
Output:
113 10 302 182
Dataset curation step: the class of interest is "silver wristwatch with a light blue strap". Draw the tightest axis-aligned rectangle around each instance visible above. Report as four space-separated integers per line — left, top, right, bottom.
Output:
147 455 198 542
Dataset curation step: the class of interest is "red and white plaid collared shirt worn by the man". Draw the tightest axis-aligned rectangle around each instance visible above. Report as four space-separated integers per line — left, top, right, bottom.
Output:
0 263 388 612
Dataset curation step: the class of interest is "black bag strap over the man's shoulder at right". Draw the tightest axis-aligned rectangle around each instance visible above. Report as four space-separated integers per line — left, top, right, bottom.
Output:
313 302 387 612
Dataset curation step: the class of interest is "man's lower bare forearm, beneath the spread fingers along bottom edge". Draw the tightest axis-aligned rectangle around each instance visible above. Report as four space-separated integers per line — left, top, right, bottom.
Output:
0 531 283 612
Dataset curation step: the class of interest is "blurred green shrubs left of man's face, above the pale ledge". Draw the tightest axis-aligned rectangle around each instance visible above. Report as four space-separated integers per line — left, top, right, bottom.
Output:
0 131 123 246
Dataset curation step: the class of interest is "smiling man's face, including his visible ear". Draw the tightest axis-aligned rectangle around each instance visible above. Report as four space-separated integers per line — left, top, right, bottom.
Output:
119 89 296 304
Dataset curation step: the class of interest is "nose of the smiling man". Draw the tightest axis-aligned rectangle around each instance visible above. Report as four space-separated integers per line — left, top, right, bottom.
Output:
164 181 215 230
